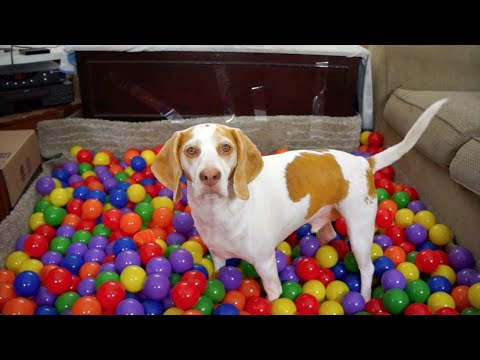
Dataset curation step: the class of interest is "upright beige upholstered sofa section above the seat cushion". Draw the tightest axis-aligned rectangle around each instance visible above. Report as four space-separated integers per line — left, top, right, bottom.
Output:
369 45 480 127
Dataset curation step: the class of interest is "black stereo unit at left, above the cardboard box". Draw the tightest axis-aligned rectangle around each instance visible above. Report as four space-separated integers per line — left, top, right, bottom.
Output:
0 61 74 116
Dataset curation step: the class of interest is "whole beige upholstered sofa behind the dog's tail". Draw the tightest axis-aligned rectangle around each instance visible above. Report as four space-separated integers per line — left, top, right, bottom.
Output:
369 45 480 268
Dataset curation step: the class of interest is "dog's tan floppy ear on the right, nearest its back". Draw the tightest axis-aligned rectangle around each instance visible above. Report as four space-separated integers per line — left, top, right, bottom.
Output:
232 129 263 200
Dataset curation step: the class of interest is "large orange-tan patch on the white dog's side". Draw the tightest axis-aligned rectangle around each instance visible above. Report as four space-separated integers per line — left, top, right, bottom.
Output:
285 153 349 219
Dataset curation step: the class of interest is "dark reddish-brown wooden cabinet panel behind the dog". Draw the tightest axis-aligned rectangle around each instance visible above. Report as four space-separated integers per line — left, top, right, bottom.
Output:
76 51 361 121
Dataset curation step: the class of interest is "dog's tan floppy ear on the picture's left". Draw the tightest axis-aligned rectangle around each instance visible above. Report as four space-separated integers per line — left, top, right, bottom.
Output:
152 131 182 202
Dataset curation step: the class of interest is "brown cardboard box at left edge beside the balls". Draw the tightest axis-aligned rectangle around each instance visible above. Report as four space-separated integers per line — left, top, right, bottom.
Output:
0 130 42 220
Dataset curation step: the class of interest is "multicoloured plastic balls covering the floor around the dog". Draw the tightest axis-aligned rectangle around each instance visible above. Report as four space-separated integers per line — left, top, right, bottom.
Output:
0 136 480 315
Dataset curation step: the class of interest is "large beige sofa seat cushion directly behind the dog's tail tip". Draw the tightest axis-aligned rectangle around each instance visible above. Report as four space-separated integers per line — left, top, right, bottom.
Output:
384 88 480 169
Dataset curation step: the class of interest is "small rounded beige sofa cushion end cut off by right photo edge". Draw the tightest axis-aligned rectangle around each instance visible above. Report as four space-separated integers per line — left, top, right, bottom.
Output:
450 137 480 196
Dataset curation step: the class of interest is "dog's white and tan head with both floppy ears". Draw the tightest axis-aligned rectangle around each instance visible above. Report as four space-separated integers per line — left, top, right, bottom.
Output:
152 124 263 202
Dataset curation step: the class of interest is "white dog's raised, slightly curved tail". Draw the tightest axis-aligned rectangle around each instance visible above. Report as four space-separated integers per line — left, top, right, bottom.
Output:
369 98 448 172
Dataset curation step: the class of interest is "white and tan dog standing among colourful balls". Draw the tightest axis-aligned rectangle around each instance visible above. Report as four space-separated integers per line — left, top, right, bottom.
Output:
151 99 447 301
